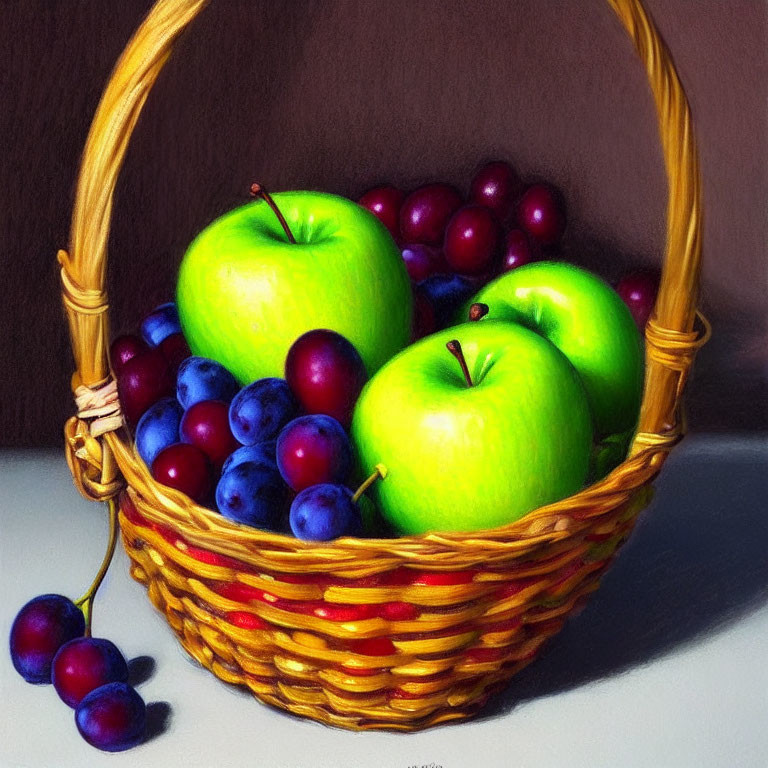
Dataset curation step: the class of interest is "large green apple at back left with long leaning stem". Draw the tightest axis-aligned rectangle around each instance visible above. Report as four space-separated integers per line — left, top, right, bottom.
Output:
176 192 412 384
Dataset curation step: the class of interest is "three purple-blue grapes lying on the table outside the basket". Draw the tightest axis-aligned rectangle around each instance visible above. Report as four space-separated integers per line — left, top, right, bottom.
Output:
10 594 147 752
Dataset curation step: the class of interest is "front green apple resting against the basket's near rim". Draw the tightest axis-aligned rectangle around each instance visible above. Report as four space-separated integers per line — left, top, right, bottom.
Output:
351 320 592 534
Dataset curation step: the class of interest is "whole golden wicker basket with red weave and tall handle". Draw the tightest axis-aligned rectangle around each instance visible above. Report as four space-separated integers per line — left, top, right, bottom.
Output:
59 0 708 730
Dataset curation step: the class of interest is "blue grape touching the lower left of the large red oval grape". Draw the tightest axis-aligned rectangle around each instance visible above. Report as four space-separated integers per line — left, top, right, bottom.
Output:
229 378 298 445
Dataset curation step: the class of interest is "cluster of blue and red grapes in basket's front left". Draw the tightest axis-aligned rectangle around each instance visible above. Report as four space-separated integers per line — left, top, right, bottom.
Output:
110 303 378 541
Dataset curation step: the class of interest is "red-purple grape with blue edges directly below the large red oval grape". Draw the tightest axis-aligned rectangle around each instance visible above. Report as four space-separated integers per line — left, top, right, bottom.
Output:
276 414 352 491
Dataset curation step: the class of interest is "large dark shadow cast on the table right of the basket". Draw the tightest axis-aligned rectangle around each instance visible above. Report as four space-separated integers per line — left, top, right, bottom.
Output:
478 450 768 719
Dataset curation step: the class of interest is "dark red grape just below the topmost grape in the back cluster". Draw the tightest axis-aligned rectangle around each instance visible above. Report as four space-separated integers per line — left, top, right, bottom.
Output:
443 205 499 275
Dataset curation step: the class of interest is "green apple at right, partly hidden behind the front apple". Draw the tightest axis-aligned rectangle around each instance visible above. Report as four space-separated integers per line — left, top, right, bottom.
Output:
463 261 644 437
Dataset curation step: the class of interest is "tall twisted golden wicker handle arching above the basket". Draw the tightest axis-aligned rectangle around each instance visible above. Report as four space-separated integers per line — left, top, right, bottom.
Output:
58 0 701 498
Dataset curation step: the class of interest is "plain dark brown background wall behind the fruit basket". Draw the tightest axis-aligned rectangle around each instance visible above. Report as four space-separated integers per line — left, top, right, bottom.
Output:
0 0 768 445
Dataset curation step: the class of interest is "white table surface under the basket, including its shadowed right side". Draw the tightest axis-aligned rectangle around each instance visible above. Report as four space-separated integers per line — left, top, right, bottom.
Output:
0 436 768 768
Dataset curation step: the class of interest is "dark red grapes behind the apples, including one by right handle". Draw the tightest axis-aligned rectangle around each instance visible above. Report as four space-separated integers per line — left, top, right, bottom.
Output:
358 160 658 332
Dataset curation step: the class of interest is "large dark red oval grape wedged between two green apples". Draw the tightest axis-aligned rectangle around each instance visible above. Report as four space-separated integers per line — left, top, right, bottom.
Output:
285 328 368 427
